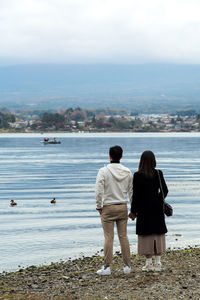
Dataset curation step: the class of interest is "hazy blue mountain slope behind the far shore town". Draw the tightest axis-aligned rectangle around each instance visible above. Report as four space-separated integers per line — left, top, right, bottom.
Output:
0 64 200 113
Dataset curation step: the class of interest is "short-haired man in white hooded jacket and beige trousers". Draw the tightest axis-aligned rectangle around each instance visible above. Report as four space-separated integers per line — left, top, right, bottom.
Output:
95 146 133 275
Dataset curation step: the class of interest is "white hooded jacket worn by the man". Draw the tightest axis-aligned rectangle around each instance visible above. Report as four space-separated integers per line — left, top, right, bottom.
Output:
95 163 133 209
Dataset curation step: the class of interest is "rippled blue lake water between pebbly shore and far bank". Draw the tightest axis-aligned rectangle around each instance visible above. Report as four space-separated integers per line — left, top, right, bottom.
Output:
0 134 200 271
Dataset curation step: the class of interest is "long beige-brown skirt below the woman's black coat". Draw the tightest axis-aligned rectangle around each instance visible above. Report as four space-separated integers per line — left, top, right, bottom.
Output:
138 234 166 255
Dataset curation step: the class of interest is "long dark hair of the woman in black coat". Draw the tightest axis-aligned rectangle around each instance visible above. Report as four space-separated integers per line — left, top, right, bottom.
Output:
138 150 156 177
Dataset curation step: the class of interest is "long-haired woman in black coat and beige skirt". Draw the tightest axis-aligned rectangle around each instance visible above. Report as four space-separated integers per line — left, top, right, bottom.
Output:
129 151 168 271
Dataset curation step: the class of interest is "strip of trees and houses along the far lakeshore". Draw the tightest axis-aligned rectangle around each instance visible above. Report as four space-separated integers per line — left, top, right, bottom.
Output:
0 107 200 132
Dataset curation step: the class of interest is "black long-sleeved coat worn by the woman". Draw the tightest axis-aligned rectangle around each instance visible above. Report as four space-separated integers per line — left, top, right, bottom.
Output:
131 170 168 235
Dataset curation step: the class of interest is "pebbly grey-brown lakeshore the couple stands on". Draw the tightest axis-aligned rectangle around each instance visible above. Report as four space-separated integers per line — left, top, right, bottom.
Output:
0 248 200 300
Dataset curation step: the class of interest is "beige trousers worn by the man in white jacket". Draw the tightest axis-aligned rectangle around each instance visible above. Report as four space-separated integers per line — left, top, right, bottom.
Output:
101 204 130 266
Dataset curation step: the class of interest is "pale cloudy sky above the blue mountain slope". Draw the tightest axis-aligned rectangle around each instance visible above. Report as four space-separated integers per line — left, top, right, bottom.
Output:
0 0 200 65
